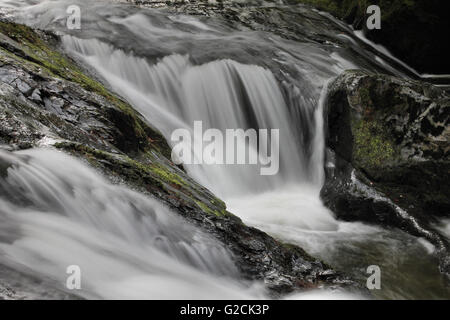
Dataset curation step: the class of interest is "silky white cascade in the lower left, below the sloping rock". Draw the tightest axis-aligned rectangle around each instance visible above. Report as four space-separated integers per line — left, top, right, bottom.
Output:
0 149 261 299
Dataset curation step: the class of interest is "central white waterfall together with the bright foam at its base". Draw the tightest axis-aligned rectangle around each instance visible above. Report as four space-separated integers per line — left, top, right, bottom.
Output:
56 17 349 245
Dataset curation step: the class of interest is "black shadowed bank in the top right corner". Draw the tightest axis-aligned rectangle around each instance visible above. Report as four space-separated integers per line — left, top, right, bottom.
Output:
287 0 450 74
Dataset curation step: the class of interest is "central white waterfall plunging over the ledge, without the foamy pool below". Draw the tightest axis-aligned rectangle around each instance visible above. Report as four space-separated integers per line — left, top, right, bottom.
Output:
63 36 323 197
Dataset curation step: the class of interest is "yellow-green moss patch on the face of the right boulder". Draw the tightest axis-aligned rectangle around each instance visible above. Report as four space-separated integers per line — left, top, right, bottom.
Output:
352 119 395 169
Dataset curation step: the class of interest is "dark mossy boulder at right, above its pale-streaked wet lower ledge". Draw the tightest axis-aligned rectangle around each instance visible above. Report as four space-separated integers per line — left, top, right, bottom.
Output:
326 70 450 220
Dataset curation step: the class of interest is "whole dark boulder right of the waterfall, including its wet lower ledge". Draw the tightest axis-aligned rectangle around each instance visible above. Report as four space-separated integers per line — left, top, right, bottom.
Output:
321 71 450 274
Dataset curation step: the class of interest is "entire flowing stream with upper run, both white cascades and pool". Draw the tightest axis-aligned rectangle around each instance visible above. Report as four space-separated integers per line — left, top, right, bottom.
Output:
0 0 449 298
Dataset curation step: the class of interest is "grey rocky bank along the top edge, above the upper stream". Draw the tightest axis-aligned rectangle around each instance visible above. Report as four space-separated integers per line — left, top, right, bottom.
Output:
122 0 356 45
